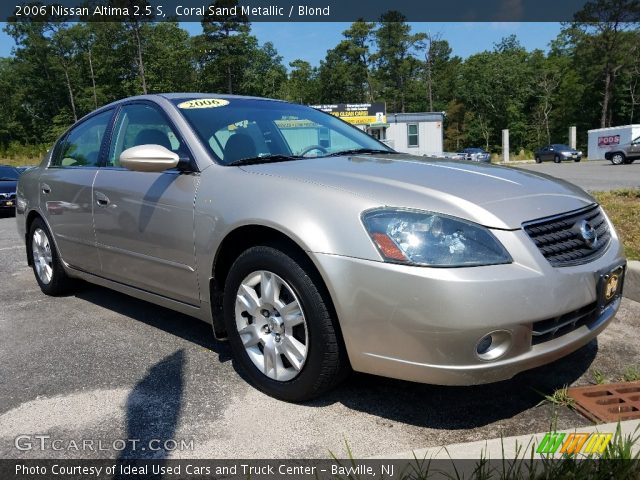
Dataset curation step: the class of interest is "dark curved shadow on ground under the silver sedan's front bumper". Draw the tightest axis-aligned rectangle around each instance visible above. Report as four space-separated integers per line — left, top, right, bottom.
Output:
309 340 598 430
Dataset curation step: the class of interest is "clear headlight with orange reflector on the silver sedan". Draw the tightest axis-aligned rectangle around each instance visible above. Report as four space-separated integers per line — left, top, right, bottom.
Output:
362 208 512 267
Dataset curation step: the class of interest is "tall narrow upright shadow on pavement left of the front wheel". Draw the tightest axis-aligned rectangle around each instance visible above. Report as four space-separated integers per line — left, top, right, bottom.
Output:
114 350 185 480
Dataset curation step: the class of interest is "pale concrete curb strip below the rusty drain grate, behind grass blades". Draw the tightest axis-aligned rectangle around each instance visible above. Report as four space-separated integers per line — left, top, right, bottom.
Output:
373 420 640 460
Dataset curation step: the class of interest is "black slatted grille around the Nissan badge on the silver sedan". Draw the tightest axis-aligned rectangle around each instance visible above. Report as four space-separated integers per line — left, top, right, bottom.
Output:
522 205 611 267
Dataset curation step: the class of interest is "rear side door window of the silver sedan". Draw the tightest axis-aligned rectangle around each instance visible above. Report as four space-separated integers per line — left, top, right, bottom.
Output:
51 110 113 167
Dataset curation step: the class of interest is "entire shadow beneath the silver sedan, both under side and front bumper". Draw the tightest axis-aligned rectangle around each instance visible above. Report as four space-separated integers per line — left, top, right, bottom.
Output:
76 284 598 432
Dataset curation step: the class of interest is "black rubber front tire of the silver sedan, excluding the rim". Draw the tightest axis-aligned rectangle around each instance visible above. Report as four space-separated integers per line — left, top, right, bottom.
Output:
224 246 349 402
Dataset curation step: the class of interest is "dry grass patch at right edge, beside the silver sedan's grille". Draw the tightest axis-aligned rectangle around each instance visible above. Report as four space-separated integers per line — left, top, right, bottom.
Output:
593 189 640 260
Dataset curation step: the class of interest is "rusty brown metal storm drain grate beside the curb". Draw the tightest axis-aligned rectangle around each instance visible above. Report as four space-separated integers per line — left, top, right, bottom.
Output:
567 381 640 422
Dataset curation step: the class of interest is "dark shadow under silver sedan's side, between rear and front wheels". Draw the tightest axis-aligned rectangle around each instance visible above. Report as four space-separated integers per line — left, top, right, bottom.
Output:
74 282 231 362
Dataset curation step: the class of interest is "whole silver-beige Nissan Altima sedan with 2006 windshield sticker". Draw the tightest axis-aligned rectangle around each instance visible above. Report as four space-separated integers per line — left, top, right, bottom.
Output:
16 94 625 401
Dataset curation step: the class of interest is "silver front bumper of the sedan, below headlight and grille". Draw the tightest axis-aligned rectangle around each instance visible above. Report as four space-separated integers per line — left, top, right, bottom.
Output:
313 230 624 385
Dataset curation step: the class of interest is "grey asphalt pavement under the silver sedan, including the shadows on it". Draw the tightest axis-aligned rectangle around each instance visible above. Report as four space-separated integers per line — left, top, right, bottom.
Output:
0 217 640 458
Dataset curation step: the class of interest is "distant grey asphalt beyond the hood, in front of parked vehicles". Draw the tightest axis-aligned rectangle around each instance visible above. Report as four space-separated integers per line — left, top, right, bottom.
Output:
513 160 640 192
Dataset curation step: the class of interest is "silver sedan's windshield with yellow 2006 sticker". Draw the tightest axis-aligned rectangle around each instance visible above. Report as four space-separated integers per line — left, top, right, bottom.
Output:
174 97 393 165
